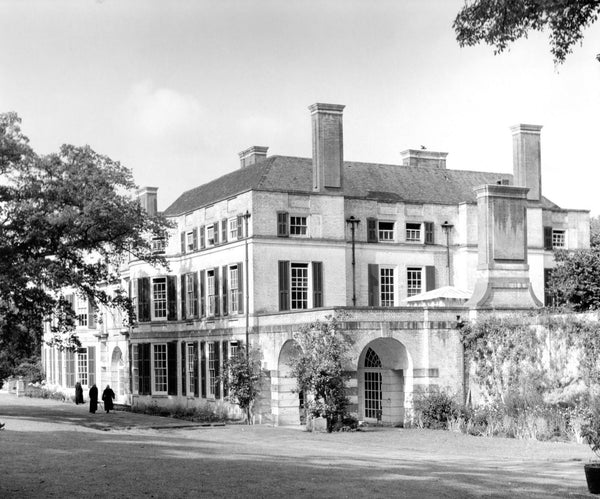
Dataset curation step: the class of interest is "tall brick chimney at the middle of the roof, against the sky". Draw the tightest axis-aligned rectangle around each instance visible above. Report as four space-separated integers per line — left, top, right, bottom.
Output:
308 103 345 192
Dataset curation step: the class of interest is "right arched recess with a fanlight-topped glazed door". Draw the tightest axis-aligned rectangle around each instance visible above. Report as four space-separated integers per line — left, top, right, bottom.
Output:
357 338 412 425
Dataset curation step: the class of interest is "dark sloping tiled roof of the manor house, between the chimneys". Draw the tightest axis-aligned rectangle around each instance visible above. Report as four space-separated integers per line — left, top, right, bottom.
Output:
165 156 558 216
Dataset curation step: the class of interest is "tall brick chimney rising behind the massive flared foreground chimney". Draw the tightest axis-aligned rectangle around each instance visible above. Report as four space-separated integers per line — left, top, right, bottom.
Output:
510 124 542 201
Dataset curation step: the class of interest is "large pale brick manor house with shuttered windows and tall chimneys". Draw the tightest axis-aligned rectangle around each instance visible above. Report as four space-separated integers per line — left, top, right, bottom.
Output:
43 104 589 424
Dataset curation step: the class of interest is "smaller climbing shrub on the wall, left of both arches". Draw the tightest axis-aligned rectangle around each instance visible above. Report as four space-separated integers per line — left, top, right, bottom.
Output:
223 348 261 424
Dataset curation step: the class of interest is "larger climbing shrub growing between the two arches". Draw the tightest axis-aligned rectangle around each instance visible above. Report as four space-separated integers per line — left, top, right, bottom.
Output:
291 316 351 431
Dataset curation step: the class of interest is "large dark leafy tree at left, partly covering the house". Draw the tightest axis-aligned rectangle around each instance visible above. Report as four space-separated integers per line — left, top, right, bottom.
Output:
0 113 168 379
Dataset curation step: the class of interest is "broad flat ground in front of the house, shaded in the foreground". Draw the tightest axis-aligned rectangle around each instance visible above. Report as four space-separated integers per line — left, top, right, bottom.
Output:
0 392 593 498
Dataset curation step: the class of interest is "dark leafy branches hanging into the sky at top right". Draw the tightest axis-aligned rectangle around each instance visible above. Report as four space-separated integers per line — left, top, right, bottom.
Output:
453 0 600 64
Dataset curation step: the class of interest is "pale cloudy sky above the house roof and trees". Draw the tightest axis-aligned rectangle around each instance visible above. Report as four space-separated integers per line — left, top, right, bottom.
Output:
0 0 600 215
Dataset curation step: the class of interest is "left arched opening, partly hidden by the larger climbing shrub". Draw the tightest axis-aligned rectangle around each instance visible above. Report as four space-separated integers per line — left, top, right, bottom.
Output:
274 340 305 425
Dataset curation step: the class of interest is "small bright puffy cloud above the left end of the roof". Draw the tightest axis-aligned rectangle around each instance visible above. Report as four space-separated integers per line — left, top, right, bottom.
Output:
126 81 204 137
